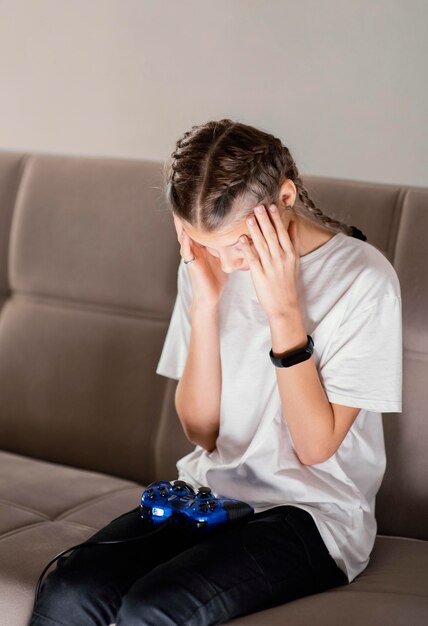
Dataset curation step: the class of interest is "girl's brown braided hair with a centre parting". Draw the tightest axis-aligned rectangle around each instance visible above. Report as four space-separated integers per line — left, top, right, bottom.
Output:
164 119 367 241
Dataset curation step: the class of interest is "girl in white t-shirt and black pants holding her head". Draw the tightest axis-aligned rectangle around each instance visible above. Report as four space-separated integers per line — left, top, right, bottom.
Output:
31 119 402 626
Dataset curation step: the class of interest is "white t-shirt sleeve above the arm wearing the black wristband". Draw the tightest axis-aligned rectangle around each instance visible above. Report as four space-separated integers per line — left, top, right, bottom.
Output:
319 295 403 413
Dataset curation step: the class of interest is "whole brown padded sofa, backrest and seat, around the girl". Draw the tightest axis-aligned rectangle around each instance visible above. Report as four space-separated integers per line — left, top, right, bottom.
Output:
0 151 428 626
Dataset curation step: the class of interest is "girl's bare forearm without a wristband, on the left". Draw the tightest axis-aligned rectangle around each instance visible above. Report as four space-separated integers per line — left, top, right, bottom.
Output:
175 303 221 452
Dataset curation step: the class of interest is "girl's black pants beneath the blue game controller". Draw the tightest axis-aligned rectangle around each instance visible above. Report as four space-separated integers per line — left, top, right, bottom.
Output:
30 505 348 626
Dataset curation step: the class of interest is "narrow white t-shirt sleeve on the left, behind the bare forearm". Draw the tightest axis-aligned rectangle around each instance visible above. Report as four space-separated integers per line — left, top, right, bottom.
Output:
156 260 192 380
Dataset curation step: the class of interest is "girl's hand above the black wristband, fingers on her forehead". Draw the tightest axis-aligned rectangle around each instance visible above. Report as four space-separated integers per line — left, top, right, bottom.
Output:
240 204 300 318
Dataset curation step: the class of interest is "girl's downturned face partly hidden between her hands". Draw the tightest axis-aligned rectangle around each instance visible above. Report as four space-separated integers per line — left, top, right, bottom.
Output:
180 220 254 274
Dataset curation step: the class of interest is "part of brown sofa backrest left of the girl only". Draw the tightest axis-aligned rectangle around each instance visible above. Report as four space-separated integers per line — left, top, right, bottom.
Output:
0 153 190 482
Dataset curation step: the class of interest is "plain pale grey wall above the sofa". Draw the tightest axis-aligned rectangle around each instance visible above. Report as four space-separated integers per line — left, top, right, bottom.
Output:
0 0 428 186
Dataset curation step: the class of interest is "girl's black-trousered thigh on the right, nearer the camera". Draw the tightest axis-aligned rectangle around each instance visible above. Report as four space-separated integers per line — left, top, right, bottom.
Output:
116 506 347 626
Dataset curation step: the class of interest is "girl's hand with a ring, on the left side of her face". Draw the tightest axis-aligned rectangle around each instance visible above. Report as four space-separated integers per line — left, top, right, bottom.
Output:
172 213 228 306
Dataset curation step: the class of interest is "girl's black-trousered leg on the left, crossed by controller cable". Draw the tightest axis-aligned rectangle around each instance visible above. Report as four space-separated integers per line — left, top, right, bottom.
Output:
31 507 201 626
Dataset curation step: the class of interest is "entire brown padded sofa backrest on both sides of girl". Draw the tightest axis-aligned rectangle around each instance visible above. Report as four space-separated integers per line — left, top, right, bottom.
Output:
0 151 428 539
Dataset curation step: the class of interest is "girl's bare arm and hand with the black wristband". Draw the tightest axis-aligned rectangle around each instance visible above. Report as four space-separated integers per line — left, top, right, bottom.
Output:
240 204 360 465
